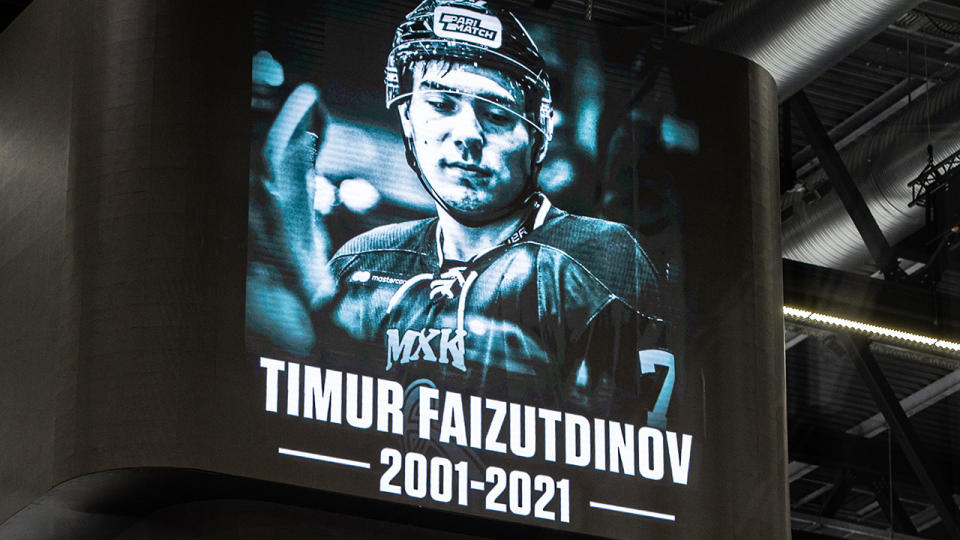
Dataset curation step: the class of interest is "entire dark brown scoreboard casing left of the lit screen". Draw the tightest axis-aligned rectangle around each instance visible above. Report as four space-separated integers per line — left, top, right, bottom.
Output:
0 0 251 520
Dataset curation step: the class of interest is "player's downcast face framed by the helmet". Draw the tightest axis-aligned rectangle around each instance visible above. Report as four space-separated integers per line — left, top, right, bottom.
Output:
400 62 532 214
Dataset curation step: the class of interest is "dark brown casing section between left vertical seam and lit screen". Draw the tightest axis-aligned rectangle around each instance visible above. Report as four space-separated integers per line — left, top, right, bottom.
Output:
57 1 250 479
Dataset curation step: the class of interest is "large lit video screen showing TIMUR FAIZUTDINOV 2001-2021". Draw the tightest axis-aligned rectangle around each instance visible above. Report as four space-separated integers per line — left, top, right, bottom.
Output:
245 0 776 538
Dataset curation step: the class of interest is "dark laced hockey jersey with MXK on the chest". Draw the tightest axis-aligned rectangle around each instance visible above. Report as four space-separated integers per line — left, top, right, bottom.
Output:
318 199 661 421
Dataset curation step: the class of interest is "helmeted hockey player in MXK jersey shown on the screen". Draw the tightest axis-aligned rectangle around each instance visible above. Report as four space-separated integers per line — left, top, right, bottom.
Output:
318 0 661 415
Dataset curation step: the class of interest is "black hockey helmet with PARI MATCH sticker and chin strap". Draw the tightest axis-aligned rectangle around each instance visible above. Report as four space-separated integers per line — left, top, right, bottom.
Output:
384 0 553 226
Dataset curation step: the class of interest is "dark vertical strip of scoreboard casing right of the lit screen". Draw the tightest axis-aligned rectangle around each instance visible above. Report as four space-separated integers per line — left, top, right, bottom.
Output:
680 53 790 538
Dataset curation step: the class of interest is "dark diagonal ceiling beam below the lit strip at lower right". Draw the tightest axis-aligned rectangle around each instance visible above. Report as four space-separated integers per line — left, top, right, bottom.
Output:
839 336 960 540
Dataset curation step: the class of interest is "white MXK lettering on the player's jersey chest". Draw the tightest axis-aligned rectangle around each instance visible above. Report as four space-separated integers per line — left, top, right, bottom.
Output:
387 328 467 371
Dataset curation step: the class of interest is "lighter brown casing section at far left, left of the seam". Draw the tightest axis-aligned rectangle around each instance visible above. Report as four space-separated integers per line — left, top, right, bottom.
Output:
0 1 76 520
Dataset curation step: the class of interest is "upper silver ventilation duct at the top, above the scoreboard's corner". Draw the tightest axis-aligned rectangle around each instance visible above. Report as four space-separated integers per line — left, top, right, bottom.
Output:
684 0 920 101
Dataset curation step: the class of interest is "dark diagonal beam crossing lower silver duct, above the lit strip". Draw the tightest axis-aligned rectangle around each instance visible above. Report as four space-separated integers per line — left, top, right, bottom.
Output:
790 90 902 277
